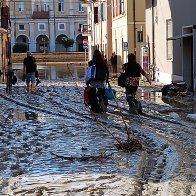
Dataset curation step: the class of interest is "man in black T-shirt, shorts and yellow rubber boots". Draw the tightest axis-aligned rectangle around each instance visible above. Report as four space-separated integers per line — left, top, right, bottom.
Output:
23 51 37 93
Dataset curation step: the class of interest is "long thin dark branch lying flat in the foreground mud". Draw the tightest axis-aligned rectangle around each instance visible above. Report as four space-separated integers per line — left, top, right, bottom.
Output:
51 152 108 162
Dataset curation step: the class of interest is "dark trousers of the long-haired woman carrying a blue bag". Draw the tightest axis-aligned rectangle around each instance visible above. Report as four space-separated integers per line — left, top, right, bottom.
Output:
89 88 108 113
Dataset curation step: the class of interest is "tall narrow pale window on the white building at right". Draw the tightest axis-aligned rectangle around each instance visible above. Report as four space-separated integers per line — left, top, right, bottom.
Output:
166 19 173 60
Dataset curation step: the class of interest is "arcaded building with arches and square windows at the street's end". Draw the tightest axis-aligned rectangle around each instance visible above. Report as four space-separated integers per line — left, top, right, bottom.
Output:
9 0 87 52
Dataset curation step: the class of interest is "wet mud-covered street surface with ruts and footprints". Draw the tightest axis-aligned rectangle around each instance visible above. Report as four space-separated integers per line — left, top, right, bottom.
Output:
0 65 196 196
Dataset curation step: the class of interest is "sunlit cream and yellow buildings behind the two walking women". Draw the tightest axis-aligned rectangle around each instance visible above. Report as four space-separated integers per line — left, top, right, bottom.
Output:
82 0 145 69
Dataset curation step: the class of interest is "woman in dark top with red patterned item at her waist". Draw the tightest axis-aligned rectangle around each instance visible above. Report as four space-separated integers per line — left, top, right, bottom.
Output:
122 53 151 113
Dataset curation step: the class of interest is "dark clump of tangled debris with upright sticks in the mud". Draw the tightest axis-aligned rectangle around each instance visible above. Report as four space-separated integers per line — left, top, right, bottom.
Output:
117 138 143 152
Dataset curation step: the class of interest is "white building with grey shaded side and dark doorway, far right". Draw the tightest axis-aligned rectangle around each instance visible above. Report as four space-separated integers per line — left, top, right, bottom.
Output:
146 0 196 91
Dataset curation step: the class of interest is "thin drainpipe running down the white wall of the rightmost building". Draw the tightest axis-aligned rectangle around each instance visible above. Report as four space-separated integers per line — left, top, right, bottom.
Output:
152 0 156 81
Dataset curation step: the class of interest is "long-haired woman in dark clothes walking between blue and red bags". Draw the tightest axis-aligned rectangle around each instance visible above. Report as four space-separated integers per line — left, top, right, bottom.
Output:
86 50 109 113
